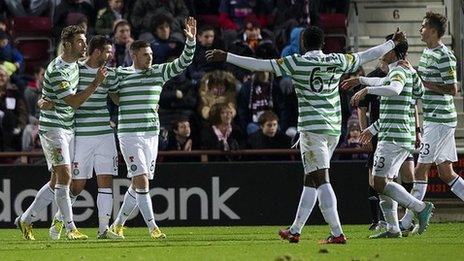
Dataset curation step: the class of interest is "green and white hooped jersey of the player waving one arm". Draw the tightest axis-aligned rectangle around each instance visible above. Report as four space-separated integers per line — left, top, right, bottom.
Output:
116 41 195 136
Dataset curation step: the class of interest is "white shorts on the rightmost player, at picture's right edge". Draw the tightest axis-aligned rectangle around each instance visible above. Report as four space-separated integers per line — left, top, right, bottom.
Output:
418 123 458 164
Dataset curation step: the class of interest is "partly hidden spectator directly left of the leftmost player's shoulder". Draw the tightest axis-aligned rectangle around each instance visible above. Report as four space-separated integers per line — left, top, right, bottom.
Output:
24 66 45 119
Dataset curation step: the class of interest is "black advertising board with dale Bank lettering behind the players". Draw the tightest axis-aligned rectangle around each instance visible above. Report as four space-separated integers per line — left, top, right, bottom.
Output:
0 161 464 228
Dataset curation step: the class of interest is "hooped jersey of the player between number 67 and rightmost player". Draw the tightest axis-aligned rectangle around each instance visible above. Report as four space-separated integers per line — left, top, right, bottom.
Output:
374 66 423 151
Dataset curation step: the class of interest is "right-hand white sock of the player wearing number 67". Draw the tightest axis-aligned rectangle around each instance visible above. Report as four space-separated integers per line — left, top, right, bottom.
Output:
317 183 343 237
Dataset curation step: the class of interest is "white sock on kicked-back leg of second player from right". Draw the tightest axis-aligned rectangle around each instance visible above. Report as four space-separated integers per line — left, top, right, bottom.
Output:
382 181 425 212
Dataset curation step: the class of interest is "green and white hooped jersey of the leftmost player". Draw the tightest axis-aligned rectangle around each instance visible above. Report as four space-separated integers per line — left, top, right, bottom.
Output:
39 56 79 132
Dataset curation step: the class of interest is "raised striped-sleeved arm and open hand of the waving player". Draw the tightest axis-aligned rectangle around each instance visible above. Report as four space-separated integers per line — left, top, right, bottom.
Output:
161 17 197 81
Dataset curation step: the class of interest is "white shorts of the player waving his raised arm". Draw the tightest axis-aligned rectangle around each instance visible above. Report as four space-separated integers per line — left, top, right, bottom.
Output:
119 135 158 179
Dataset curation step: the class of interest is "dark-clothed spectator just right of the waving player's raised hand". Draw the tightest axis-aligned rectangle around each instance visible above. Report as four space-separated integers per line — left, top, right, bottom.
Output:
187 25 225 85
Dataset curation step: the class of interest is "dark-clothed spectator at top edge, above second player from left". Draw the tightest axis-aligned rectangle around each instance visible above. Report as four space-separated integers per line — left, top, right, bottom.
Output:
95 0 127 36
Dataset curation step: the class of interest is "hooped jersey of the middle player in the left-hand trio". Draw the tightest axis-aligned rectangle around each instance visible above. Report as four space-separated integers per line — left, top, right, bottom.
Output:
75 63 118 136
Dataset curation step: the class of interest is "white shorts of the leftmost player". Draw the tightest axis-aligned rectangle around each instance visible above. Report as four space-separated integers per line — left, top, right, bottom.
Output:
39 129 74 171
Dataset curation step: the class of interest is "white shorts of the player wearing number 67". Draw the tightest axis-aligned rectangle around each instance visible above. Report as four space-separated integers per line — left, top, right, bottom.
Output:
300 132 340 174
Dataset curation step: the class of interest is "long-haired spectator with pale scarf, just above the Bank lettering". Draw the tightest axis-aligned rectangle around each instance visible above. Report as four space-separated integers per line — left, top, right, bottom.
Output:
201 103 246 156
